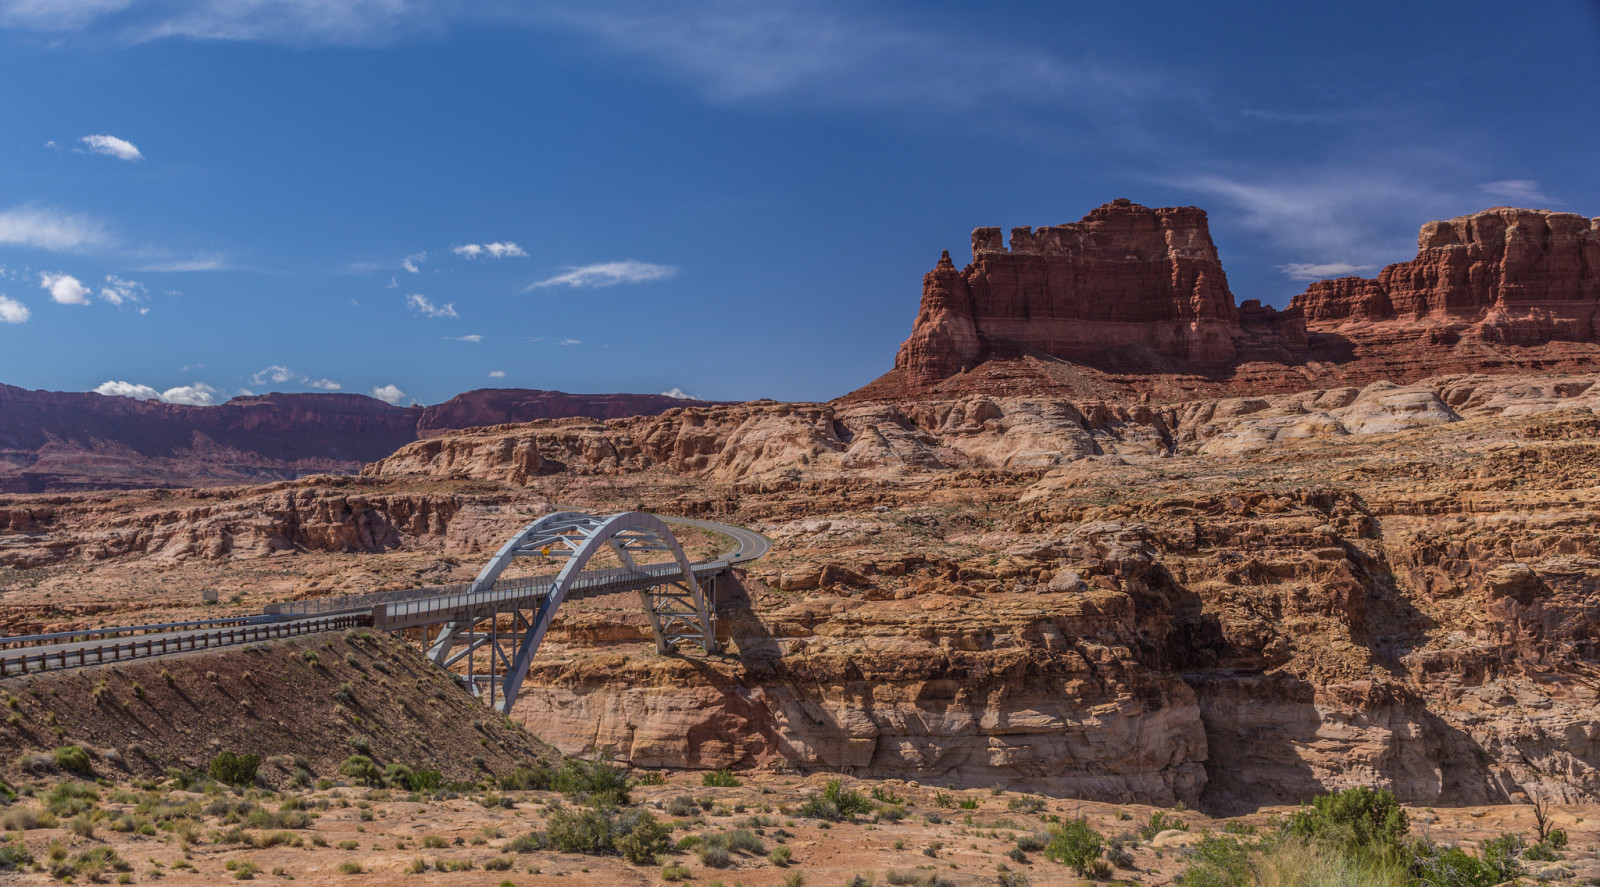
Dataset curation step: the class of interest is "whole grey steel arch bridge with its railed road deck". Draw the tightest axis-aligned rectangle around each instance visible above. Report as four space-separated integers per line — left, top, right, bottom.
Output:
0 511 771 712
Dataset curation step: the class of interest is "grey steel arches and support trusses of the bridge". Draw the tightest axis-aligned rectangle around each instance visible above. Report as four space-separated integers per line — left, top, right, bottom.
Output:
422 511 718 712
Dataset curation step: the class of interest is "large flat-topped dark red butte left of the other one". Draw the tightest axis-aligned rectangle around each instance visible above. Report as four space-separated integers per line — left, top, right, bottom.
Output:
894 200 1304 384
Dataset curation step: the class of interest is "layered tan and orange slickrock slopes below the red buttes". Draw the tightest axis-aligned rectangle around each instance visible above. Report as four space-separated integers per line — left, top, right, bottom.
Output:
9 375 1600 812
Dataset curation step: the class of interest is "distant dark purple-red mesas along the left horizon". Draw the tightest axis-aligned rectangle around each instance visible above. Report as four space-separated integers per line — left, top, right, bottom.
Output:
0 384 713 493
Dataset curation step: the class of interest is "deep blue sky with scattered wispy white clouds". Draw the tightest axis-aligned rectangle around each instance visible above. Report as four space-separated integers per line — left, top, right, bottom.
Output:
0 0 1600 403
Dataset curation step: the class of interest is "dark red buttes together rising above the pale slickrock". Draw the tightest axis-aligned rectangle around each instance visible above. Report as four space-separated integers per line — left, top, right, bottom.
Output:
851 200 1600 399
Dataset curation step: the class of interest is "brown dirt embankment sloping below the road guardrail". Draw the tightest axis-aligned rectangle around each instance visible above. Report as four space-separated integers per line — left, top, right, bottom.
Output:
0 631 550 783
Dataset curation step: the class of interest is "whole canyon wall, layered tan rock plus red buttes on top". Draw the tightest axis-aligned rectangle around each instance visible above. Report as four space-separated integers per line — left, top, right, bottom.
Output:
0 202 1600 813
